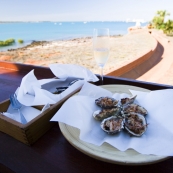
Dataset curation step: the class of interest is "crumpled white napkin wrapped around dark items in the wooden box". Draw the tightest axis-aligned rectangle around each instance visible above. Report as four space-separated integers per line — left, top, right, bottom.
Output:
17 64 98 106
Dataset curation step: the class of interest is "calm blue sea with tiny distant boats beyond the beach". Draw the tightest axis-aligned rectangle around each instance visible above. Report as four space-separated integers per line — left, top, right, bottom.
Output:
0 22 147 51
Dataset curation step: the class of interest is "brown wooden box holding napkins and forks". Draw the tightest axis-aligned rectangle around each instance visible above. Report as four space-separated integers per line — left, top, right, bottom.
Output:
0 89 79 145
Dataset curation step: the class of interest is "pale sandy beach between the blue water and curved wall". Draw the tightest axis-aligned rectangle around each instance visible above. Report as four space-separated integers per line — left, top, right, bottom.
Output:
0 31 155 74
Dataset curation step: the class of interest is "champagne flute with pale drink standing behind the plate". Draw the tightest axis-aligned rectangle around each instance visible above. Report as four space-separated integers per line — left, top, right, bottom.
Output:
93 28 110 85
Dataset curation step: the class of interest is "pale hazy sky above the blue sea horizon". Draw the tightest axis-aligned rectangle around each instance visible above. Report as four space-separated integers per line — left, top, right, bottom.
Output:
0 0 173 21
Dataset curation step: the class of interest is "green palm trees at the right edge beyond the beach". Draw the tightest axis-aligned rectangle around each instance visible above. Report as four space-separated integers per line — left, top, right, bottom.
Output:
151 10 173 35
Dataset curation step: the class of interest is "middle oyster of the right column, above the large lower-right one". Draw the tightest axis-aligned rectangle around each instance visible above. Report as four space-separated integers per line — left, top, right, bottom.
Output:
123 103 148 115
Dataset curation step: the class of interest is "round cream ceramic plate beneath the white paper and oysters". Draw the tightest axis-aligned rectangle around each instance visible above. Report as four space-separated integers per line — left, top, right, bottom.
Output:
59 85 170 165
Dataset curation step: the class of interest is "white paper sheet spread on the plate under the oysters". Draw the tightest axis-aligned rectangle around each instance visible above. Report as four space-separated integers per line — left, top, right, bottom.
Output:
51 82 173 156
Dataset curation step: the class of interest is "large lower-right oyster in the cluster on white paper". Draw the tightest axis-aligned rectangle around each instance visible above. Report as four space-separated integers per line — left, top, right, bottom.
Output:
124 113 147 136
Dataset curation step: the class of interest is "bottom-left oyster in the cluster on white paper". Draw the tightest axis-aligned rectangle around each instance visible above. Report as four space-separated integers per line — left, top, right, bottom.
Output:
101 116 123 135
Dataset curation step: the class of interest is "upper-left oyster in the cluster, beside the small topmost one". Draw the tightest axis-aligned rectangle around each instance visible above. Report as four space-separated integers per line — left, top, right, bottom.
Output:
95 97 118 109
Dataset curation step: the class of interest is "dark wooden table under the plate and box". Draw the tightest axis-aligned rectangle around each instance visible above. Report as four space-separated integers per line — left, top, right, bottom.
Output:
0 62 173 173
